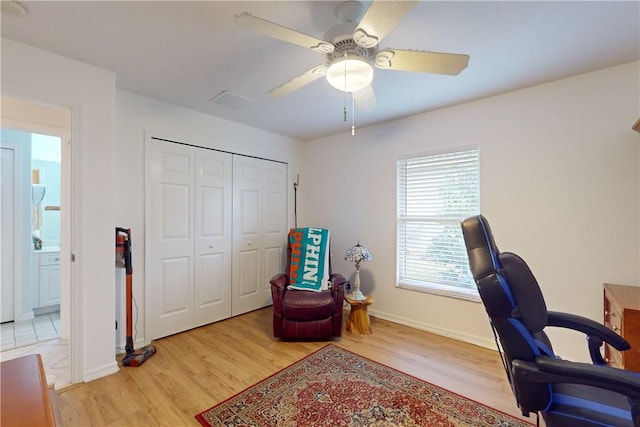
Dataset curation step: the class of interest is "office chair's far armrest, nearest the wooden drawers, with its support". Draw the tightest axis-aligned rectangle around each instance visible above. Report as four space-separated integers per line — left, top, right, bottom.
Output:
547 311 631 365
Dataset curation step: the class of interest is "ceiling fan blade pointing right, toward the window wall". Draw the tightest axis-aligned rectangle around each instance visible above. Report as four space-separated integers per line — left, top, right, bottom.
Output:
375 49 469 76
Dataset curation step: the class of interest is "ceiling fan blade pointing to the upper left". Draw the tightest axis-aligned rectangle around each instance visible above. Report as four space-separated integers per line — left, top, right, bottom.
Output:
234 12 334 53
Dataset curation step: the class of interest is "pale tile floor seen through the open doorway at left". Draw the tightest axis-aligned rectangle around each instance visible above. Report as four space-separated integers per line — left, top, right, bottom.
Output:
0 312 70 390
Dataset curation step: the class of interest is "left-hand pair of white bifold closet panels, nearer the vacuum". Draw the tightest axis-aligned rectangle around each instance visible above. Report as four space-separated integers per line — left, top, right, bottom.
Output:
145 139 233 340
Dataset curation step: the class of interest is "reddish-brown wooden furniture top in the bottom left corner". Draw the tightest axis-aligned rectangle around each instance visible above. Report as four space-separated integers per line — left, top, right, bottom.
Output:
0 354 56 427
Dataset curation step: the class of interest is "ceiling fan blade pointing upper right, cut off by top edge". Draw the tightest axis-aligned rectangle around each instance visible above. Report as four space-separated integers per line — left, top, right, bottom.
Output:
353 0 418 49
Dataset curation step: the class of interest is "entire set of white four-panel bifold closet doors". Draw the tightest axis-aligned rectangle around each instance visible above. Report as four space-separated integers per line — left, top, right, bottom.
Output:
148 138 288 340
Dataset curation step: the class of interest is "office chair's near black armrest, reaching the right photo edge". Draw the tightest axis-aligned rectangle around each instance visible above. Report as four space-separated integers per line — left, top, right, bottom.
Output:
511 356 640 401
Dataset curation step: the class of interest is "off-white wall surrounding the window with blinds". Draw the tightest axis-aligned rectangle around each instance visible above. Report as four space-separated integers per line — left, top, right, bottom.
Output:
299 62 640 360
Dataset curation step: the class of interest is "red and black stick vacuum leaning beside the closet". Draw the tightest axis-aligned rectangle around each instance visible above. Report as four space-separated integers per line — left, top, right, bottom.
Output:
116 228 156 367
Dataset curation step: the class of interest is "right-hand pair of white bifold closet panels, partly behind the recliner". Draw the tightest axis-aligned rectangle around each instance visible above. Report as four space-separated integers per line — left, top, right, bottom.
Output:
231 156 288 316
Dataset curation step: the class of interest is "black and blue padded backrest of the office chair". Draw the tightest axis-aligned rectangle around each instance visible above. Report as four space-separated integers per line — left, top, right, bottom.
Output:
462 215 553 413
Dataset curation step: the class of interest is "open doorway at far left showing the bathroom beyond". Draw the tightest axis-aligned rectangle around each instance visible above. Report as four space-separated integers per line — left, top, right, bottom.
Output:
0 97 71 388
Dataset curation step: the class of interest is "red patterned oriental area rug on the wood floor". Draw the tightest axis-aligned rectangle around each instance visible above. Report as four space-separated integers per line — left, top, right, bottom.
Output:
196 344 532 427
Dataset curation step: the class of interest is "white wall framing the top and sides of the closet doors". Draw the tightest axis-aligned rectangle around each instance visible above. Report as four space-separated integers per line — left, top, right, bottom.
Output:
115 91 301 347
